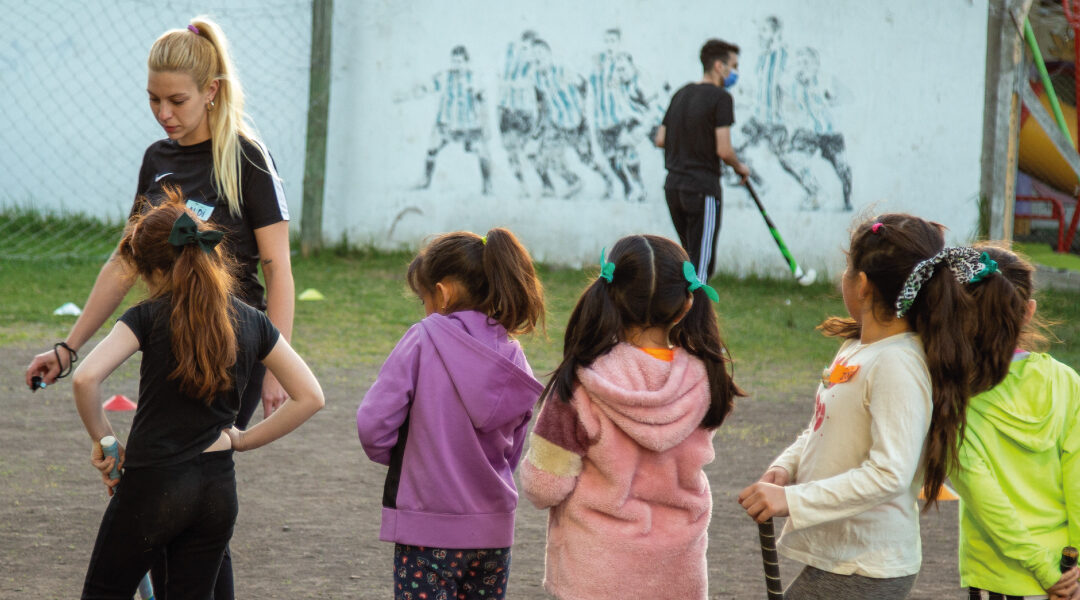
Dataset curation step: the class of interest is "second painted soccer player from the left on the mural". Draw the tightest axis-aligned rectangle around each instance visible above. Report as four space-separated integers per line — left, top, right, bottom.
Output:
499 29 540 196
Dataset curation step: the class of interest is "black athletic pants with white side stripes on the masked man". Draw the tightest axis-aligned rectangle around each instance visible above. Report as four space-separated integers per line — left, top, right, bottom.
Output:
664 190 721 282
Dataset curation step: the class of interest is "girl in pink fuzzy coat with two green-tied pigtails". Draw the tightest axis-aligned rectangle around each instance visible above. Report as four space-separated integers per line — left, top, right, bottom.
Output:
522 235 743 600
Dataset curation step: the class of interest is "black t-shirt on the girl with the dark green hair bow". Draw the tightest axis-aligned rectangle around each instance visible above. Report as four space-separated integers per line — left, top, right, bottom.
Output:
120 297 279 467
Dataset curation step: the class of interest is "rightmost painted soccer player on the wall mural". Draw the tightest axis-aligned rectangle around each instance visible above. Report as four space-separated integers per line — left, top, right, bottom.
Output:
785 47 851 210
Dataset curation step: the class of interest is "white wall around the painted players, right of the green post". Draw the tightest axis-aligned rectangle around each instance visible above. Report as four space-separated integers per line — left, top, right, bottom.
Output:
324 0 987 275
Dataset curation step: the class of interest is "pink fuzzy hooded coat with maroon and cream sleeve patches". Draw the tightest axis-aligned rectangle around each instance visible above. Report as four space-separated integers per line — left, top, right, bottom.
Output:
522 344 715 600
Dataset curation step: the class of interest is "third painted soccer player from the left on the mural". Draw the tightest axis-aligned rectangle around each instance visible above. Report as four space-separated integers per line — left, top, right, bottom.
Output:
532 39 611 197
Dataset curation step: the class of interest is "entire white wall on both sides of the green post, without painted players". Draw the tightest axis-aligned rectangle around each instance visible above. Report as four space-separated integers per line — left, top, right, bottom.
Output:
0 0 987 275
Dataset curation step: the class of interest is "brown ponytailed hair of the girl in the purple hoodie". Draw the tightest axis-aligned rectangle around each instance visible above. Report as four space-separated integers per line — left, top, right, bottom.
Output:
407 228 544 335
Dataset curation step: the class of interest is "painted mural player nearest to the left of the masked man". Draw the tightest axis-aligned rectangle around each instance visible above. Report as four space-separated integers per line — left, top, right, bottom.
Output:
589 29 663 202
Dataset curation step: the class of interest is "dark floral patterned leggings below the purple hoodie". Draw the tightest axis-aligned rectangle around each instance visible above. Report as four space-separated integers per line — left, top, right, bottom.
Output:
394 544 510 600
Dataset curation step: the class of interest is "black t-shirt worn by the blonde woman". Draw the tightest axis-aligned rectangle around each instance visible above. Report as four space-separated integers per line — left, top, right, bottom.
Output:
131 137 288 311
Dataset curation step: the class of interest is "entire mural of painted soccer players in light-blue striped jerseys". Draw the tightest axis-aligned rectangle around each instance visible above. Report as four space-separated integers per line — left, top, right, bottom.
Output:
395 16 852 210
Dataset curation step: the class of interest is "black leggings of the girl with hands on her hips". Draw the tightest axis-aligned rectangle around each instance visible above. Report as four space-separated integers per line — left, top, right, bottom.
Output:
82 450 238 600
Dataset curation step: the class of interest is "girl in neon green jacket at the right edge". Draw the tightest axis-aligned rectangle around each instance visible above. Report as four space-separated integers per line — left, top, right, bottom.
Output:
949 247 1080 600
